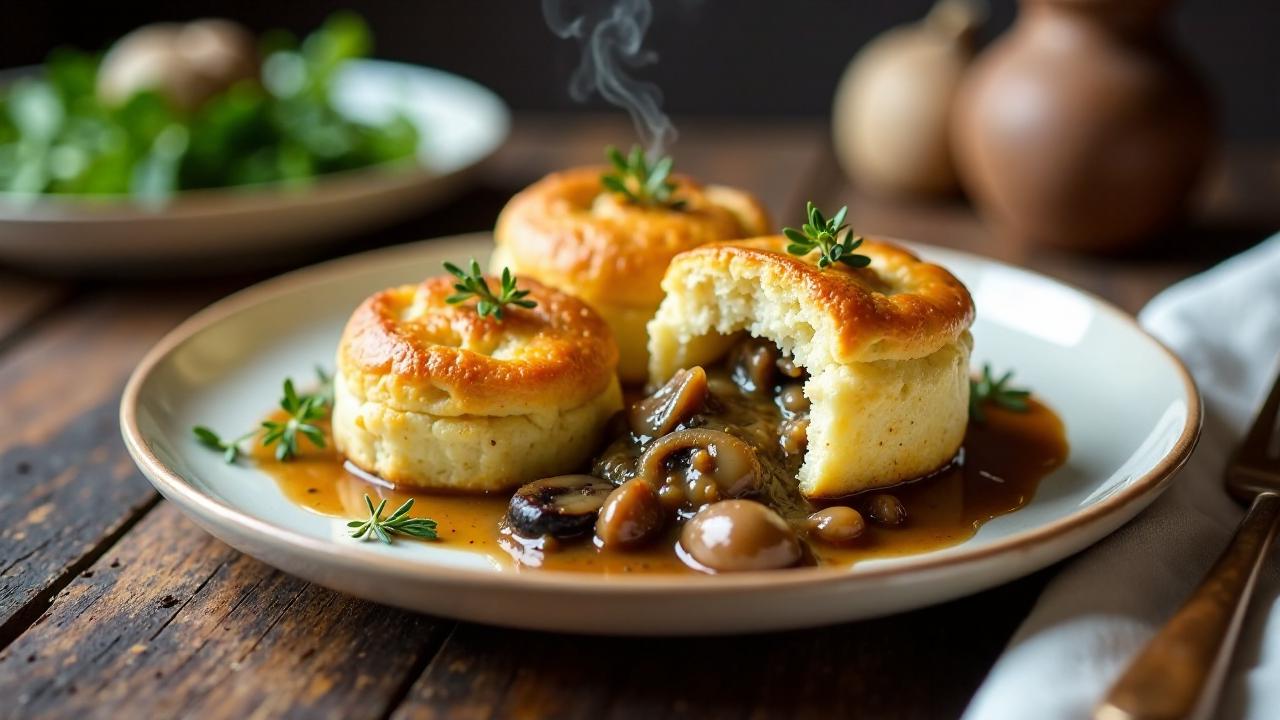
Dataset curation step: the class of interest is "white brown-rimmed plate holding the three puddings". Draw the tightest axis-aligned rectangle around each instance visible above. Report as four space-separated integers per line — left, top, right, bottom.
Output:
120 236 1201 634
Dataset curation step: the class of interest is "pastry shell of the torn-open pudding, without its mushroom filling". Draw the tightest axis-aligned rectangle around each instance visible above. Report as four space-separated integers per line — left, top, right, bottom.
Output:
649 237 974 498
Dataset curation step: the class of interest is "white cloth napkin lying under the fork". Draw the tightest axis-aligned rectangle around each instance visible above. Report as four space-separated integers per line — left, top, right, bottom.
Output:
965 236 1280 720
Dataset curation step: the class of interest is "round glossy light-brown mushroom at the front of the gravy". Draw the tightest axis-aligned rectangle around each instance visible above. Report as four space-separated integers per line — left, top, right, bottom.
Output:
680 500 804 573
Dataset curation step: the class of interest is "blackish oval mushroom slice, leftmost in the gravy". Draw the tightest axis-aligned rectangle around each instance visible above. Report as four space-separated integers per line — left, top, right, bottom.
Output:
507 475 613 538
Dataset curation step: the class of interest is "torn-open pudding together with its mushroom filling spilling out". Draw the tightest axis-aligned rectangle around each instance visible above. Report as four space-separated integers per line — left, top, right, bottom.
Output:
494 225 974 573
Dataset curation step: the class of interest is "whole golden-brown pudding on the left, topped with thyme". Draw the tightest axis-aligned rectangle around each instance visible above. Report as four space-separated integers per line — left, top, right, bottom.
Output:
333 271 622 492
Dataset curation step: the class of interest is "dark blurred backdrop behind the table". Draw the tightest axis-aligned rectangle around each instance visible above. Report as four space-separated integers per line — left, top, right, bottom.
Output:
0 0 1280 140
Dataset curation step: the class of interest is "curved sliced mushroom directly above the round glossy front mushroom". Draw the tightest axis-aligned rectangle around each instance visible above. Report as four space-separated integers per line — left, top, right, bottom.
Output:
636 428 764 498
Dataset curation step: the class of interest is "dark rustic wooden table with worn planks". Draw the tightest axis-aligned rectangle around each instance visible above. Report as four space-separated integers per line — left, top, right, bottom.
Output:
0 117 1280 719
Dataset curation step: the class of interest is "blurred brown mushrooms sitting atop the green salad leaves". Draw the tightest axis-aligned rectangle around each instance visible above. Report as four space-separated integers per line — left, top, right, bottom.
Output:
97 19 259 111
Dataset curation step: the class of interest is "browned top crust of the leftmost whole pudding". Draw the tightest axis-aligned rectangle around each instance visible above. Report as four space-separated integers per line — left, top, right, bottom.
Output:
338 275 618 416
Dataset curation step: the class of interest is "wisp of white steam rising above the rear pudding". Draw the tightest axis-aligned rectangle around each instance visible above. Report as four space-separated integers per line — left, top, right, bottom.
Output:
543 0 676 154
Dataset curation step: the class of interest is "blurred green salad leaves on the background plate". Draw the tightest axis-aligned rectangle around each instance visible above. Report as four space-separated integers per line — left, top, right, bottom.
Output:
0 13 420 202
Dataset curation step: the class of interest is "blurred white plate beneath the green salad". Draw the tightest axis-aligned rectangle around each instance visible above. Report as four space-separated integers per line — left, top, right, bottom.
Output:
0 60 511 273
